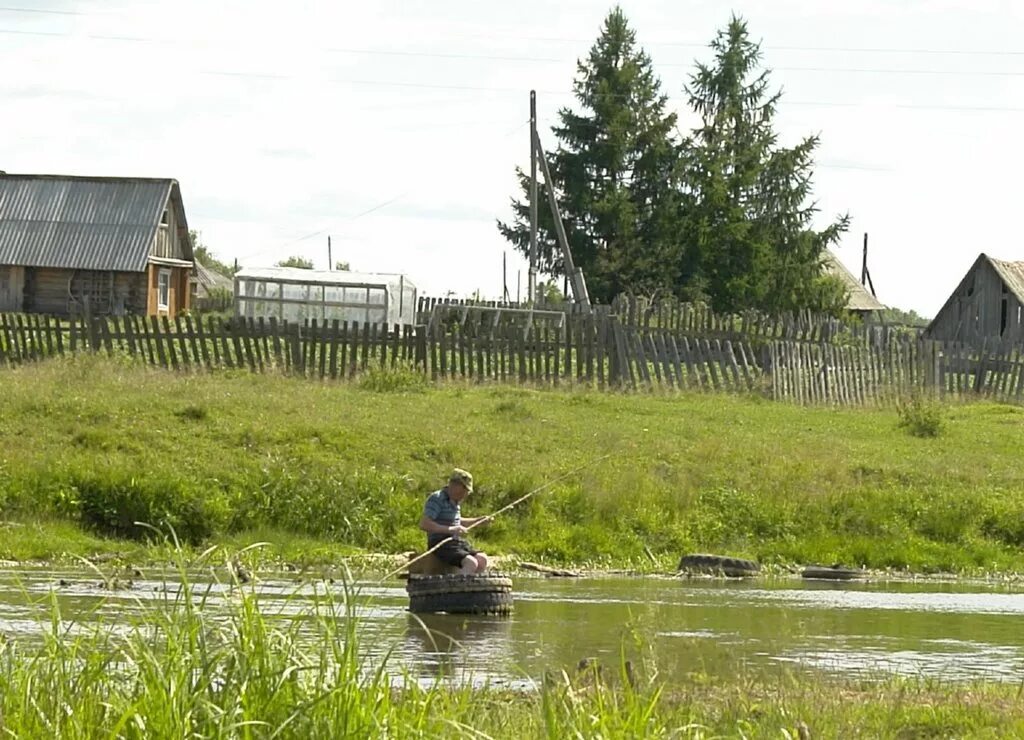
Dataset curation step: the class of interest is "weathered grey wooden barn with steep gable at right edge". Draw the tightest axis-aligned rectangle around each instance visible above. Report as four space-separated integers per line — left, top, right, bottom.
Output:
925 254 1024 347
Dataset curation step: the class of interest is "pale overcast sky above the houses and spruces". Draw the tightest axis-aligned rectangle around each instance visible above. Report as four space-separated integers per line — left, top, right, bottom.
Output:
0 0 1024 316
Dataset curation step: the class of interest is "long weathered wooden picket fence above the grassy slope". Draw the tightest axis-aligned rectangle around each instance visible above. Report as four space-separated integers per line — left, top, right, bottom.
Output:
0 304 1024 405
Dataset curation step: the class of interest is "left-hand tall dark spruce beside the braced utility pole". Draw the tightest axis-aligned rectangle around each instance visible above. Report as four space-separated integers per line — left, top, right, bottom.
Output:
498 7 680 303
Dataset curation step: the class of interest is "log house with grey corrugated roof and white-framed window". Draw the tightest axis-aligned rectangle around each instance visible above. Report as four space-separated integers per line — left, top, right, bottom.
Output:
0 173 193 316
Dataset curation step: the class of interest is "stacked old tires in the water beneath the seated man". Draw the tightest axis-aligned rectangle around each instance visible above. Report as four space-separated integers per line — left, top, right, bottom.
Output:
406 573 512 614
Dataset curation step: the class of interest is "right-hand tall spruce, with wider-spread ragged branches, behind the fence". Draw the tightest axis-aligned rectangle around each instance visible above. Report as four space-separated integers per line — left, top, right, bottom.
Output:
680 16 848 312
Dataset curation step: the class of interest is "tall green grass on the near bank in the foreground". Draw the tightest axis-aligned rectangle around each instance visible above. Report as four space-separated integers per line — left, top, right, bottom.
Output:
0 556 1024 739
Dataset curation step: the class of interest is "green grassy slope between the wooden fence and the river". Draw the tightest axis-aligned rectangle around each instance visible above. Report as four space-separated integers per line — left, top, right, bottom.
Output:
0 357 1024 573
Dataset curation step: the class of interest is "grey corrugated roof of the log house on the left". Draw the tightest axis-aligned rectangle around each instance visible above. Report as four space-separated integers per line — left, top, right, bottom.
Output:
0 175 175 272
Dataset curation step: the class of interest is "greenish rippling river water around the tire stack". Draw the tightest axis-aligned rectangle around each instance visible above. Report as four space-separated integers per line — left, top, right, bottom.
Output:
0 569 1024 686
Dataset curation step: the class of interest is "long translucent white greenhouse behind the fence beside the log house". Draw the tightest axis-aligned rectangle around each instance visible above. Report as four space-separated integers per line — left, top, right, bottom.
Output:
234 267 416 324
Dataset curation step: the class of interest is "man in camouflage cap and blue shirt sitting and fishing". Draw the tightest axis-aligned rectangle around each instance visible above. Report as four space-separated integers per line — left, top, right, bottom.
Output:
420 468 490 575
